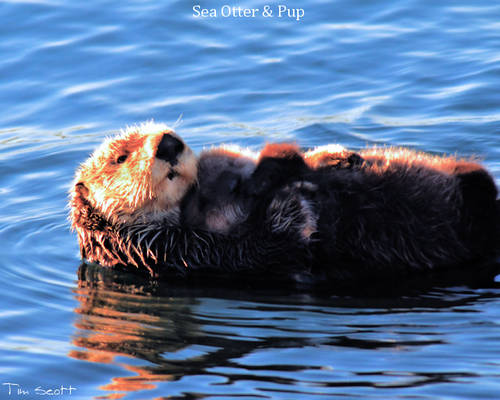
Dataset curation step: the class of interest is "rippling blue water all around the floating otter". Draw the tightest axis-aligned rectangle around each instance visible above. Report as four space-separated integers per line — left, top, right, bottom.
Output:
0 0 500 399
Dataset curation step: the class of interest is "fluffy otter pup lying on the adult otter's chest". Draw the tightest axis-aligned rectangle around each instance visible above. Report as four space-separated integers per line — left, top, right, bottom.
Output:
181 143 363 240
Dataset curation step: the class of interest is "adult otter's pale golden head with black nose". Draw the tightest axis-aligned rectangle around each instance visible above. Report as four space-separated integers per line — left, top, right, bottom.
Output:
70 122 197 228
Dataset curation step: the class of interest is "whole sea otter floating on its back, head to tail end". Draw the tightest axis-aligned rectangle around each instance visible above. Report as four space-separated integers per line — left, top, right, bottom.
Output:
70 124 500 284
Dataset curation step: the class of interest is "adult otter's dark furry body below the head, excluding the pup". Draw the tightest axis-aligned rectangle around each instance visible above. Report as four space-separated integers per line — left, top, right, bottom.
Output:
71 138 500 285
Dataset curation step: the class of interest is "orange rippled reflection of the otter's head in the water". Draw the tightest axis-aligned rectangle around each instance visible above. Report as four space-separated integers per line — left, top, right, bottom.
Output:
70 264 208 397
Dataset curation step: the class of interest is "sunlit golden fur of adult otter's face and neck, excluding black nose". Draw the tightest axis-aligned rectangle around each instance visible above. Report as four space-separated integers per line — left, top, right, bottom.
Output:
70 122 197 265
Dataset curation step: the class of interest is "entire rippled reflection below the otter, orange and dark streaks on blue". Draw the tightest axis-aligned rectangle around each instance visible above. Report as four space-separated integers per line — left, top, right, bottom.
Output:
70 265 499 399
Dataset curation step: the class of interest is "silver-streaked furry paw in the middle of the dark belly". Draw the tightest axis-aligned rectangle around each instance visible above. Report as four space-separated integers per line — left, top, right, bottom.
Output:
267 181 318 243
